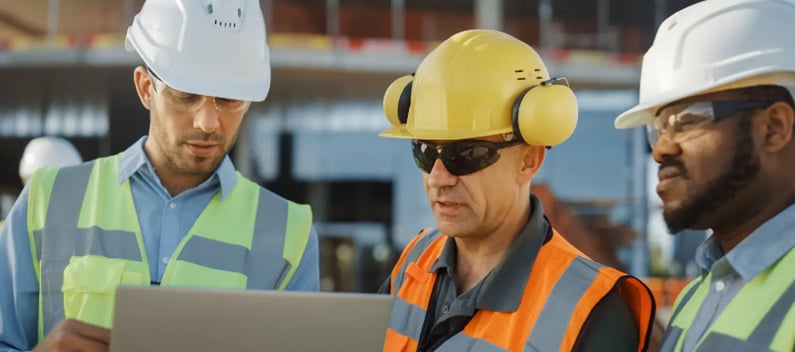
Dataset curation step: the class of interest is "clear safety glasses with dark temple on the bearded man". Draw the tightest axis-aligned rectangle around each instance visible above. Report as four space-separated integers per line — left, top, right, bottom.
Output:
646 101 774 148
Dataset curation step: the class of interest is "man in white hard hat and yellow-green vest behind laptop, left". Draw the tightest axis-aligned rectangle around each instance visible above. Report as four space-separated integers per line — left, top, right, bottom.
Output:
0 0 319 351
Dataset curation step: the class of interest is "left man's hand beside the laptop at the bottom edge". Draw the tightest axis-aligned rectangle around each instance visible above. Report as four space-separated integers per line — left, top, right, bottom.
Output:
33 319 110 352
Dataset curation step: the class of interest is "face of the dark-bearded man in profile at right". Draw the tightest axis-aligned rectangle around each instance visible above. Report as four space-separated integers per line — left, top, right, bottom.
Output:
653 94 760 233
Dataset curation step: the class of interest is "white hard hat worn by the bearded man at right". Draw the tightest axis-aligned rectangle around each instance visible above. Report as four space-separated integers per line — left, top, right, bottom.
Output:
615 0 795 128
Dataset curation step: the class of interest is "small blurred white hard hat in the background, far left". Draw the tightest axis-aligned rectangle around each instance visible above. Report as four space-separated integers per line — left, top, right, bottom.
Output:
19 137 83 180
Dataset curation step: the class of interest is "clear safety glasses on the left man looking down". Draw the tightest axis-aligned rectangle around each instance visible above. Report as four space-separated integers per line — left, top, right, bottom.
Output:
146 68 251 113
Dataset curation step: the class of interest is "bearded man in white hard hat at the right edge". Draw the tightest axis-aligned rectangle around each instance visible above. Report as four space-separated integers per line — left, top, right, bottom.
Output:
615 0 795 351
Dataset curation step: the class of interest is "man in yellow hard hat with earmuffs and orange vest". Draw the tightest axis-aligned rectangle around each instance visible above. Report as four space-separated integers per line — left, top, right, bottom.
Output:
381 30 654 351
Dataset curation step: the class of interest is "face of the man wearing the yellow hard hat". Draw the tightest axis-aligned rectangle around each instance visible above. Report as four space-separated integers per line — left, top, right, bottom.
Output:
414 136 543 238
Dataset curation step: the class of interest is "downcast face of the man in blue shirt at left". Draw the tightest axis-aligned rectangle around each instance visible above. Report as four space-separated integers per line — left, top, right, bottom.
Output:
142 69 248 175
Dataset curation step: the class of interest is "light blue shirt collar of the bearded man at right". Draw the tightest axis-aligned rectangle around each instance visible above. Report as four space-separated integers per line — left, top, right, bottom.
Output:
696 204 795 282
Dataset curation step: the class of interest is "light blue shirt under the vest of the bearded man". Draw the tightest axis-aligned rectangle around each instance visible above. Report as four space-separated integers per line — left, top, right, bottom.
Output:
682 204 795 351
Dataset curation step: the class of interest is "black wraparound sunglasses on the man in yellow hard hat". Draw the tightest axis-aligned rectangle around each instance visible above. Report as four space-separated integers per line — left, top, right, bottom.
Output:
411 139 522 176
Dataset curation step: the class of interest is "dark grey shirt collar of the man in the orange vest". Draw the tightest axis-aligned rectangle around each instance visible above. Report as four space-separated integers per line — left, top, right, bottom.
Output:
430 194 550 312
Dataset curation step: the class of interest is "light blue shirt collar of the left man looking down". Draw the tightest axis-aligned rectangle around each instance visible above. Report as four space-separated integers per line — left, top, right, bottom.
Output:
119 136 237 199
